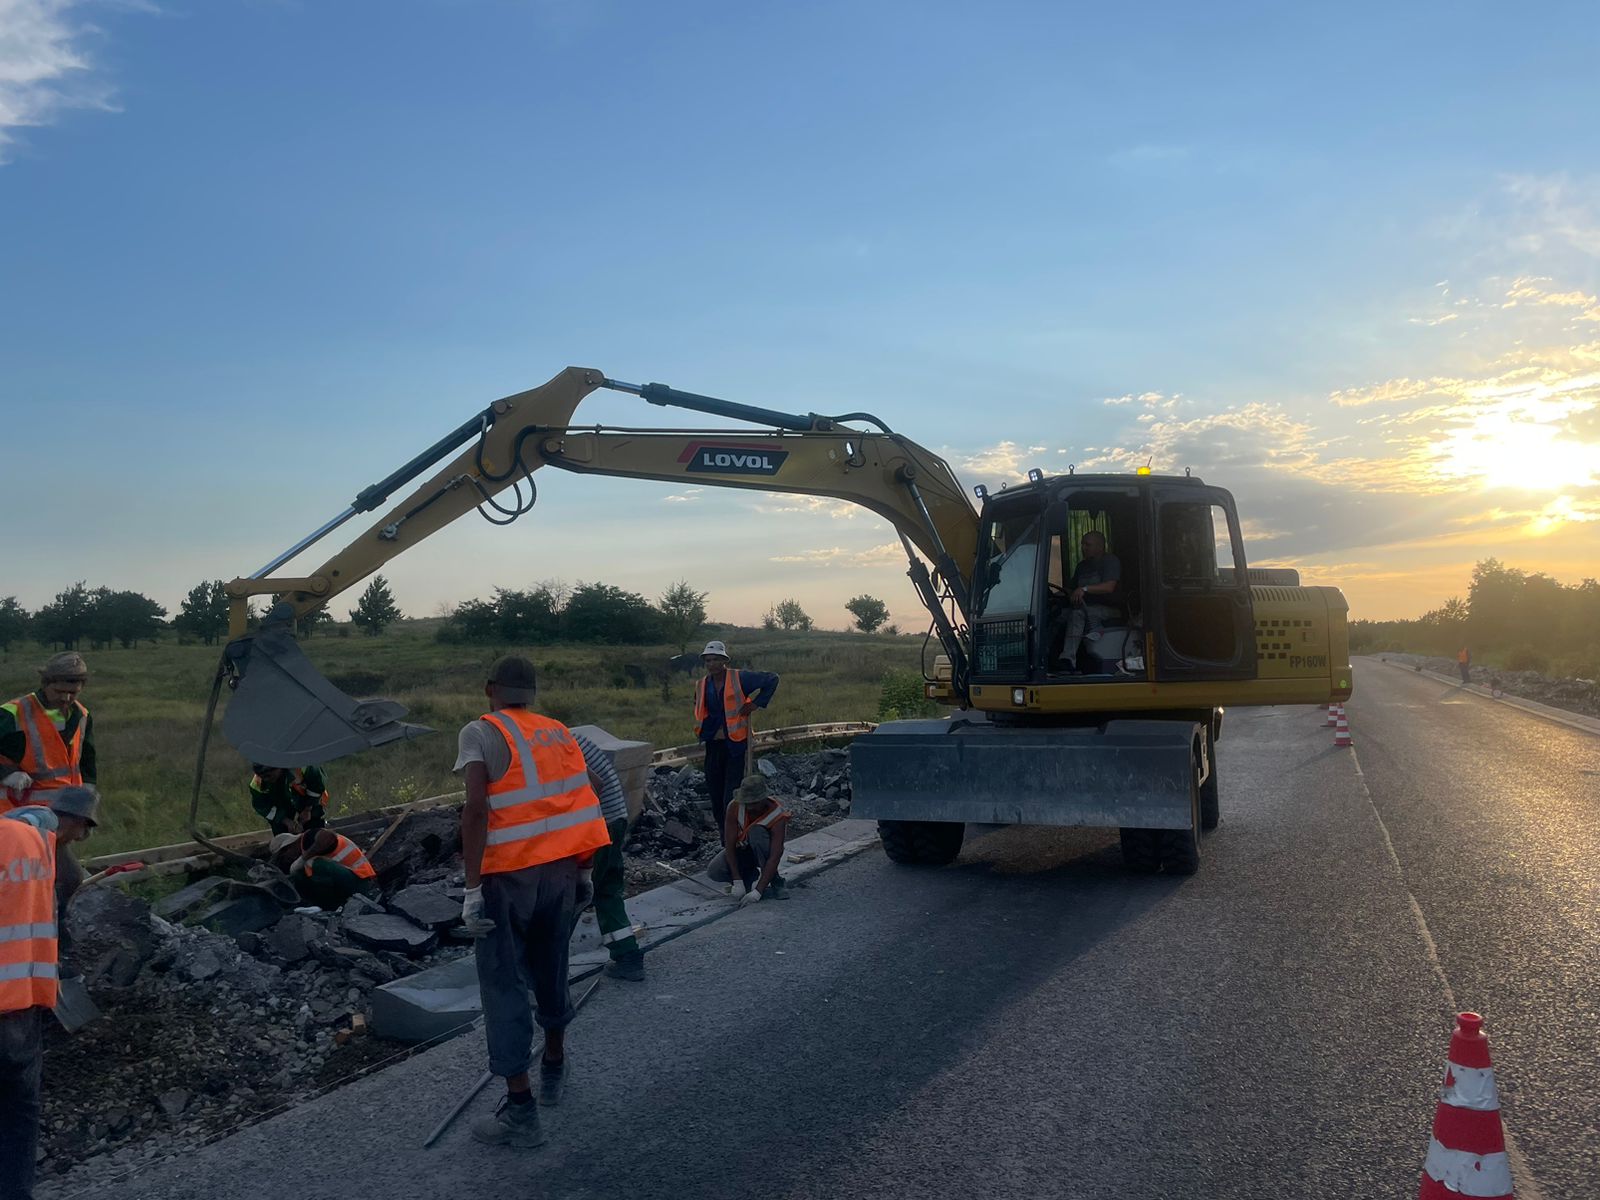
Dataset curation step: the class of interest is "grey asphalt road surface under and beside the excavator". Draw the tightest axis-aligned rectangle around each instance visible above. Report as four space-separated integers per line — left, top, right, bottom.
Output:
56 662 1600 1200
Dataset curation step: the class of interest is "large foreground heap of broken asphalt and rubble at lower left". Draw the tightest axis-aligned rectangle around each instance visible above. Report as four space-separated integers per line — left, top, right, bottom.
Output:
40 810 470 1189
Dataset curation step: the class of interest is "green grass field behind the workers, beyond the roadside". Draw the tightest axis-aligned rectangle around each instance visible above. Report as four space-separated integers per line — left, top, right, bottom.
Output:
0 621 922 858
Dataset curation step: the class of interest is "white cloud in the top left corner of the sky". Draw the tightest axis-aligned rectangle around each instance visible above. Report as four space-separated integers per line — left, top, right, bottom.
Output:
0 0 131 163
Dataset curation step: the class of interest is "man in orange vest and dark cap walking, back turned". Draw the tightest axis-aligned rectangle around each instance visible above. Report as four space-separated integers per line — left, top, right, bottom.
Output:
454 654 611 1147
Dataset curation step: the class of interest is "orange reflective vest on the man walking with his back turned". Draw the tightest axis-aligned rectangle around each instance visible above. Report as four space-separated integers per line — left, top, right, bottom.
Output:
482 709 611 875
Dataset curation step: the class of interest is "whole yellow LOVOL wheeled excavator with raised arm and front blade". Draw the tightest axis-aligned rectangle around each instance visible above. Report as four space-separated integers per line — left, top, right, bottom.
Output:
195 366 1352 874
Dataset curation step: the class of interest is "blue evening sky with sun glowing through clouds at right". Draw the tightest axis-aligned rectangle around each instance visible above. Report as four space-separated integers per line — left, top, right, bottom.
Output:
0 0 1600 626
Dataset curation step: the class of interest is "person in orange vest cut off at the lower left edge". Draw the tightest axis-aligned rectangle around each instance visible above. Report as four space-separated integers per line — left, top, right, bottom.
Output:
0 805 58 1200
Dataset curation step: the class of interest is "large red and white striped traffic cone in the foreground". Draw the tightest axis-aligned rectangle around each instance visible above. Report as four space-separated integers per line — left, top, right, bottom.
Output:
1418 1013 1512 1200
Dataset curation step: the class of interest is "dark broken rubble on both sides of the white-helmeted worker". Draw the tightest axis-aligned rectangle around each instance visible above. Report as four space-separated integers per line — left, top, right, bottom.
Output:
622 749 850 891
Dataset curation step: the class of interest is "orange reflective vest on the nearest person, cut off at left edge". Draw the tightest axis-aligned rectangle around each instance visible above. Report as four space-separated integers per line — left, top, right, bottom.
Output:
0 821 56 1013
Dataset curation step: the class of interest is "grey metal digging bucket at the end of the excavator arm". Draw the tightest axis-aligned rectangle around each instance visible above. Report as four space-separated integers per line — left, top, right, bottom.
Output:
222 622 432 766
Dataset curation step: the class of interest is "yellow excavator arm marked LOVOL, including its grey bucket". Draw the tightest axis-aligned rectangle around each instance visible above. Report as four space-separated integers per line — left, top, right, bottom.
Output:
219 366 978 765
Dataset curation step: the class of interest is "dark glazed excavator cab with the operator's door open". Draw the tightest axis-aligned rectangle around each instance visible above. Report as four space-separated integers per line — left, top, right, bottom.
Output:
971 475 1256 685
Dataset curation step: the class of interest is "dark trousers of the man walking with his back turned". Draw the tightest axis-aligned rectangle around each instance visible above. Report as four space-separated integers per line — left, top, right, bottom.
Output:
477 858 578 1077
